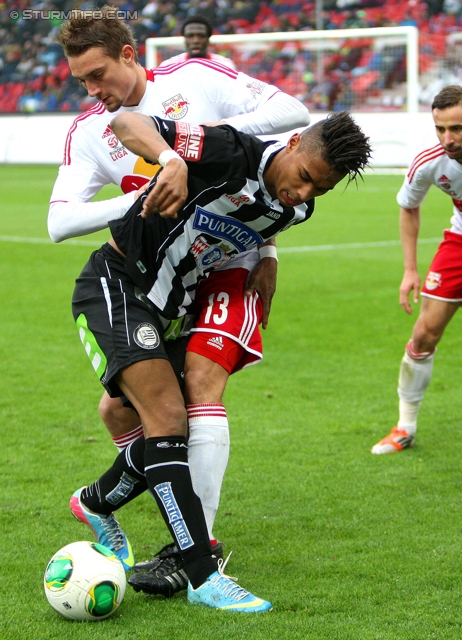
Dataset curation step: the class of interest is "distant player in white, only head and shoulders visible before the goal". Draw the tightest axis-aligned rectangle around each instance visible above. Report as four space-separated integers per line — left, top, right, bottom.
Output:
159 15 236 70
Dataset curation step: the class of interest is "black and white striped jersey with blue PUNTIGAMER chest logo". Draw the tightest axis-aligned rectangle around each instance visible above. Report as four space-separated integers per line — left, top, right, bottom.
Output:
109 118 314 318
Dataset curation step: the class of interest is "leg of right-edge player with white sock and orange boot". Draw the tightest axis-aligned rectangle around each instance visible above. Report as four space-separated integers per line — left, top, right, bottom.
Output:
372 296 460 454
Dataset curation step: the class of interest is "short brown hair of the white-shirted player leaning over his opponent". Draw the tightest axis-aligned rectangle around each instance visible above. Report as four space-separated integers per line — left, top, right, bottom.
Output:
58 4 138 62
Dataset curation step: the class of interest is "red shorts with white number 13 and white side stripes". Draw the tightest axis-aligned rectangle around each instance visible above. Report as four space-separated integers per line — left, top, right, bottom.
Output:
186 269 263 374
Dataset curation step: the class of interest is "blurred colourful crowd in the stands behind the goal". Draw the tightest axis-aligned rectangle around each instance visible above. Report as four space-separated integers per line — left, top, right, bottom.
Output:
0 0 462 113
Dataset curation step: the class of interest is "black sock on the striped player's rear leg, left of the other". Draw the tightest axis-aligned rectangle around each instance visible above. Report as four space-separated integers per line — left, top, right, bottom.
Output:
80 437 148 516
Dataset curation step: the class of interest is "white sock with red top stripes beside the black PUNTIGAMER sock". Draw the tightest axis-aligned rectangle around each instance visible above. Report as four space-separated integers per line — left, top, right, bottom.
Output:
186 404 229 540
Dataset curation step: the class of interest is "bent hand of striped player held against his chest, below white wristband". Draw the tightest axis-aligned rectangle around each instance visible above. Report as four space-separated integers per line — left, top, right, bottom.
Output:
141 158 188 218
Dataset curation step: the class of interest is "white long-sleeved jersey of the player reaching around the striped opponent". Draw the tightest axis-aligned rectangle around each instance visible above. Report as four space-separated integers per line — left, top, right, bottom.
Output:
48 58 309 242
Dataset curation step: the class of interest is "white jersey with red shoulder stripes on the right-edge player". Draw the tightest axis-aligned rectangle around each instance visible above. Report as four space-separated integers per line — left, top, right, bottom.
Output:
396 144 462 234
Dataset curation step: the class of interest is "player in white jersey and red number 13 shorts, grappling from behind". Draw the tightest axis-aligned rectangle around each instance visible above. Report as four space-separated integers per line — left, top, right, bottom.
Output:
48 7 309 596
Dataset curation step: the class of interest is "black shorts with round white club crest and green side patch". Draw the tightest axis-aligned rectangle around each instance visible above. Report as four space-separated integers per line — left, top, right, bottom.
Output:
72 244 189 397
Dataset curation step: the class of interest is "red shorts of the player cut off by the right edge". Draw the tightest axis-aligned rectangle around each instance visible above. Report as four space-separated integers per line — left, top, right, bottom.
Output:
422 229 462 302
